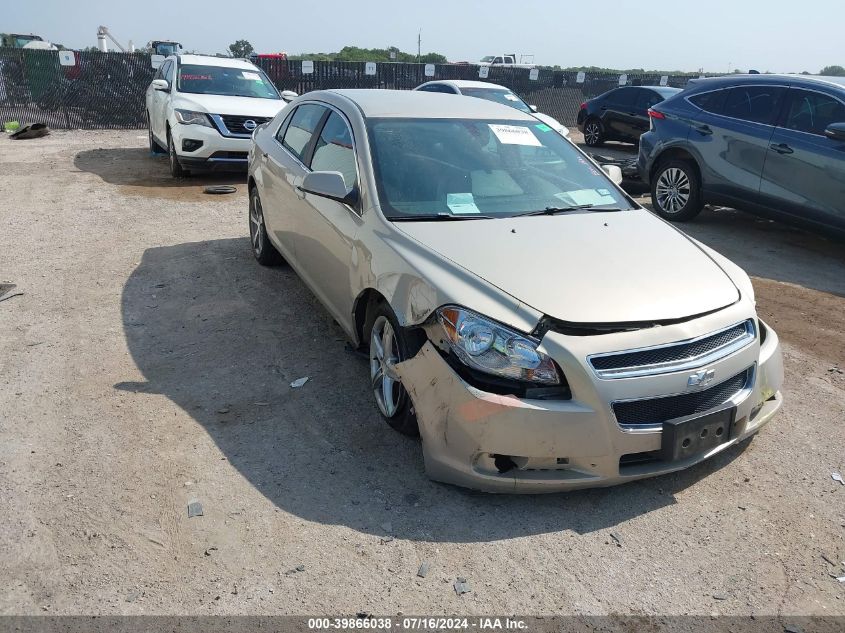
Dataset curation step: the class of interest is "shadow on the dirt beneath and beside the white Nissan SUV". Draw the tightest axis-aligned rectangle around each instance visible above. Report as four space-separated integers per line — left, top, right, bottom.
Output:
73 147 246 199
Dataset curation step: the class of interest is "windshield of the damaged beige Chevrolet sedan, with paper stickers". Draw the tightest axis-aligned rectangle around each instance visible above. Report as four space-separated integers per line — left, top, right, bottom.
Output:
367 119 632 220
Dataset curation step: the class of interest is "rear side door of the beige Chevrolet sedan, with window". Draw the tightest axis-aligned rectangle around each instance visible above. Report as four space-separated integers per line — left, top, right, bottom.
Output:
261 103 326 258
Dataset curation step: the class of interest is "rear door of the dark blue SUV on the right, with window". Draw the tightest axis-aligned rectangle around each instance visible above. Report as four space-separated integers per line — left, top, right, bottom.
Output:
688 84 786 204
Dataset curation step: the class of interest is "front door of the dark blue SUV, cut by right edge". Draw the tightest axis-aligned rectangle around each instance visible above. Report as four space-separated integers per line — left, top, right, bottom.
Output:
760 88 845 228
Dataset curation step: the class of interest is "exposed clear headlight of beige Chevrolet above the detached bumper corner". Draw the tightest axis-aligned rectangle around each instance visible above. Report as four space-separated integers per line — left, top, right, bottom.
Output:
437 306 560 385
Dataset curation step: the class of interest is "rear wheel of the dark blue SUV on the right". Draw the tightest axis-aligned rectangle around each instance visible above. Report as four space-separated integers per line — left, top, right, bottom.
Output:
651 160 704 222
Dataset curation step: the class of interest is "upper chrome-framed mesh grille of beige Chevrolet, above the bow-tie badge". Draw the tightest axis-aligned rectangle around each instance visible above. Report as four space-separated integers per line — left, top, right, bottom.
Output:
588 319 755 378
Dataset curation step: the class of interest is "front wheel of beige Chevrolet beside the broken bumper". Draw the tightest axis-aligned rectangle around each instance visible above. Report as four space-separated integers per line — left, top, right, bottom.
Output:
364 301 423 437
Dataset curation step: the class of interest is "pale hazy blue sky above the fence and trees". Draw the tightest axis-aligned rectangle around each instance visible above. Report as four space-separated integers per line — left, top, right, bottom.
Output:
0 0 845 73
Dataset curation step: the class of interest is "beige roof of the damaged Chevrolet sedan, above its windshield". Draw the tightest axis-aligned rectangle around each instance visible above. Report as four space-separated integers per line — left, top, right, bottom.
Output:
316 89 536 121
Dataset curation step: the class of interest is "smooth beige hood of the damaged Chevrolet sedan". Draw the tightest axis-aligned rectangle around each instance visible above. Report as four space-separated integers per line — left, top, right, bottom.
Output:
394 209 739 324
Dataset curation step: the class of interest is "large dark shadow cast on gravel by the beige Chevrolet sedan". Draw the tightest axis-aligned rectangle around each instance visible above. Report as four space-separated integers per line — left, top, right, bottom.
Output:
115 238 747 542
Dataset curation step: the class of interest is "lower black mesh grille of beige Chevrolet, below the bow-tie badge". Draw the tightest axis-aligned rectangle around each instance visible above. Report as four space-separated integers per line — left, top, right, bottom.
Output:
613 368 754 426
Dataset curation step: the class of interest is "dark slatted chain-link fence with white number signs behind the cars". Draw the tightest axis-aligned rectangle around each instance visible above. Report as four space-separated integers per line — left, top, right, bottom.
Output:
0 48 712 129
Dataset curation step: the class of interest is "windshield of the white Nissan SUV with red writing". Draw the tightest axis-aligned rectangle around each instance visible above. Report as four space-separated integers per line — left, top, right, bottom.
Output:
176 64 280 99
